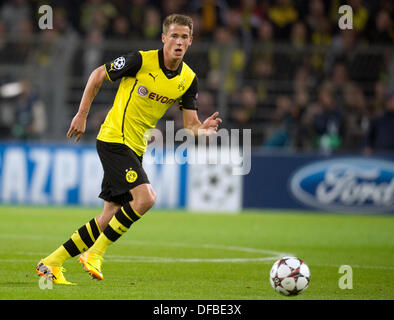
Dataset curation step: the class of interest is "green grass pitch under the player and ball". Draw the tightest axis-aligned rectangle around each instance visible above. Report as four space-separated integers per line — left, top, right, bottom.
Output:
0 206 394 300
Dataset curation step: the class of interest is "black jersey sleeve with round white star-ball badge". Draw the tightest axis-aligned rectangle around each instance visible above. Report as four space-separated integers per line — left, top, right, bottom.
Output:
105 51 142 81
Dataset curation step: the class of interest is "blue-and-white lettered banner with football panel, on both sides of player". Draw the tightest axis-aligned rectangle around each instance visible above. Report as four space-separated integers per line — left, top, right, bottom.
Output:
0 143 242 212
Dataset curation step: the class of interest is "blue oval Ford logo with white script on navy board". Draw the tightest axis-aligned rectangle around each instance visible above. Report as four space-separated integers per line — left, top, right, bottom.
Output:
289 158 394 212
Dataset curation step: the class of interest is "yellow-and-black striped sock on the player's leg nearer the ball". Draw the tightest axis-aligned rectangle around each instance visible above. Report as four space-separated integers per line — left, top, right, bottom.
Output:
89 203 141 256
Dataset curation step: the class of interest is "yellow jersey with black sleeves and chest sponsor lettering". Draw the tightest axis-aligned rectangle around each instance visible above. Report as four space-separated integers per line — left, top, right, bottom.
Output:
97 49 198 156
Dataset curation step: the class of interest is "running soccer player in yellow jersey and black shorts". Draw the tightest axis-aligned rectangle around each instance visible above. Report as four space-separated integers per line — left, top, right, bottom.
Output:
36 14 222 284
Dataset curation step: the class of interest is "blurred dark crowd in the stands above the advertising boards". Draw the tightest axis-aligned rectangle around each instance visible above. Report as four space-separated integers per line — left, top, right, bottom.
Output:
0 0 394 154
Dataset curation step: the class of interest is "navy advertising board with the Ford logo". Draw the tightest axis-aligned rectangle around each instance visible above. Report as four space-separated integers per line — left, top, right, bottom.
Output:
243 154 394 213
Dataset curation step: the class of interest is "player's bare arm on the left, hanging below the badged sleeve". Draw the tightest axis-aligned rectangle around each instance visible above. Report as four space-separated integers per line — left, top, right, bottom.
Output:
67 65 109 142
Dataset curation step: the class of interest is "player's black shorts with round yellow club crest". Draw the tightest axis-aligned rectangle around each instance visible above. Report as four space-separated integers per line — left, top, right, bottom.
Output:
96 140 150 205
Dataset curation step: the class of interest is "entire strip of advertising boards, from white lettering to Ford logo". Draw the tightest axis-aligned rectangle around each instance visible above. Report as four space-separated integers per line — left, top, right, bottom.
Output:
0 143 394 213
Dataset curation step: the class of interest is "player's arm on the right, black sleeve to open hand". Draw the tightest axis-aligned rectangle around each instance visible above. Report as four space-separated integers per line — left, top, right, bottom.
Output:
180 77 222 136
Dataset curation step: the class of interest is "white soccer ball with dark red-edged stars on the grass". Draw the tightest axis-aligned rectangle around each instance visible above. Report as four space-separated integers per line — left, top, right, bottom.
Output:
270 257 311 296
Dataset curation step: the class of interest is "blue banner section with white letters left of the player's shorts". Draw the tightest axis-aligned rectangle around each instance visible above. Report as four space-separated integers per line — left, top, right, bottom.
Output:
0 144 103 205
